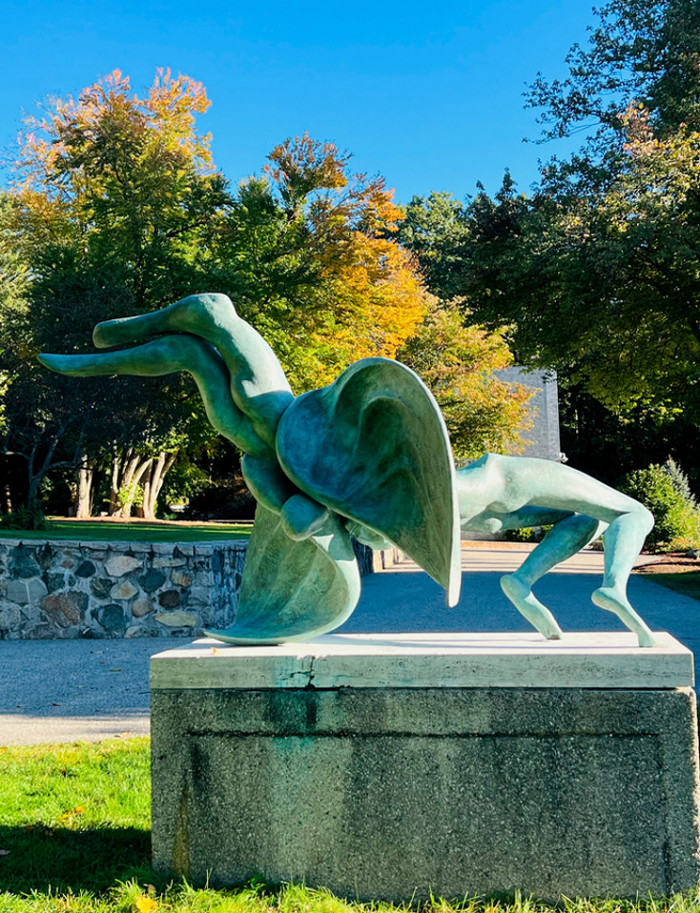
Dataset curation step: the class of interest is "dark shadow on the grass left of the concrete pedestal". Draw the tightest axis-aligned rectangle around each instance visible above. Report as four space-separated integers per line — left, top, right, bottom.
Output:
0 825 154 894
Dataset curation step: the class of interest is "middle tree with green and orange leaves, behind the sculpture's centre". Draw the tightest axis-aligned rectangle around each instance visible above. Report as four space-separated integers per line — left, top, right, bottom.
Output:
217 134 428 392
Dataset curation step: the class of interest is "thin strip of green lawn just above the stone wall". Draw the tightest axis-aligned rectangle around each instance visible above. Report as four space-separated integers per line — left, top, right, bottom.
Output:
0 518 252 540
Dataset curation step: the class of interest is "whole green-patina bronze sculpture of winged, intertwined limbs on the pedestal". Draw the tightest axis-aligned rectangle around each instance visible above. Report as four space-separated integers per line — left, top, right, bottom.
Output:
40 294 654 646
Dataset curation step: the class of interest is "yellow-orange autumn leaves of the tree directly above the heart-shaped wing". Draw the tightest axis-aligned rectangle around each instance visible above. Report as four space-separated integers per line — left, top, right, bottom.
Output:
266 134 430 389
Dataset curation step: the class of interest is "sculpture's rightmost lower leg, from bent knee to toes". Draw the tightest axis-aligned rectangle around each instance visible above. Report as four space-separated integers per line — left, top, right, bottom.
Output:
591 504 656 647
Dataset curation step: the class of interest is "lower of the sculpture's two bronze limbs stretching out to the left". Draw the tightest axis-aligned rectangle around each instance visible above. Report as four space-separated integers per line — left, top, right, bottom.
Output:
39 334 270 455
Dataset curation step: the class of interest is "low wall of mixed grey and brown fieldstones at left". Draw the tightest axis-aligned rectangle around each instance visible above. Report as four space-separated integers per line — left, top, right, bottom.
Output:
0 539 248 639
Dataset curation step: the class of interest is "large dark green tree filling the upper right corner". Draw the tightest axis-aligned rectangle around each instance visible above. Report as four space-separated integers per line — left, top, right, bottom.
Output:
394 0 700 482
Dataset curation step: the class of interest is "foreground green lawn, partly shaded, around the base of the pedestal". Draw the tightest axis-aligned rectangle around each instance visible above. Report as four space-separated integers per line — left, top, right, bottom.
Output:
0 739 700 913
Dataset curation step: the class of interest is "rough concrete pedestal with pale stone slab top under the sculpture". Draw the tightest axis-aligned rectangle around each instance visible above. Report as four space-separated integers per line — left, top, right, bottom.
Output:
151 633 700 901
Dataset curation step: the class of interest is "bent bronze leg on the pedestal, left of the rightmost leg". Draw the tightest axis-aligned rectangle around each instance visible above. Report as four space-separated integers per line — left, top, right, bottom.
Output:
501 507 603 640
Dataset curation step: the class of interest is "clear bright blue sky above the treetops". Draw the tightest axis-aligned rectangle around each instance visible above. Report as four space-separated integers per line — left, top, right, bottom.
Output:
0 0 594 202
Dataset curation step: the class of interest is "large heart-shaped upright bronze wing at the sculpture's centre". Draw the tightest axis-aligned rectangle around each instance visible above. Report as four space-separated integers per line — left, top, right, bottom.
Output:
276 358 461 605
